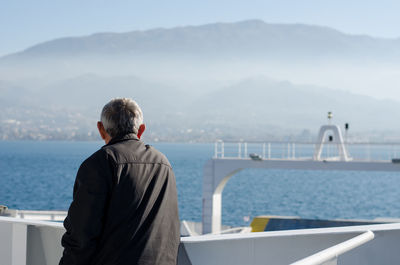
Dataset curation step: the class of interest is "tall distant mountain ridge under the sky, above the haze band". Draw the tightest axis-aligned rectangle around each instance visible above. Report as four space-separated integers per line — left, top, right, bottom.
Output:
3 20 400 60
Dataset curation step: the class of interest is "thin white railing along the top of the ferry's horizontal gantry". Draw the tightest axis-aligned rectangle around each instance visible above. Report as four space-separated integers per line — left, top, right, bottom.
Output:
214 141 400 161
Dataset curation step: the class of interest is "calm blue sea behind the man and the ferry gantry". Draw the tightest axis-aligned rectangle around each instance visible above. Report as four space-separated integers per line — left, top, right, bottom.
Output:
0 141 400 226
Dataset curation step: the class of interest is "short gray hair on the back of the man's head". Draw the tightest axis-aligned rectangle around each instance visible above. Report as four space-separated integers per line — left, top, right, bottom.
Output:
100 98 143 138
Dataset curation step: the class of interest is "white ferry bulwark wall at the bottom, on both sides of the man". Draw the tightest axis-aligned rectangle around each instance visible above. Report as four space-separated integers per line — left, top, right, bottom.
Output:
0 214 400 265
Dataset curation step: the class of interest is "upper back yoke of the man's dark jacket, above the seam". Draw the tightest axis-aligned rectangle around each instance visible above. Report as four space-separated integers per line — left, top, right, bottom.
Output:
98 140 171 167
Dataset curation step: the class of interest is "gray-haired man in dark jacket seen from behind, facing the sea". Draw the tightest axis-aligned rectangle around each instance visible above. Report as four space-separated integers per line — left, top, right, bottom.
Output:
60 98 179 265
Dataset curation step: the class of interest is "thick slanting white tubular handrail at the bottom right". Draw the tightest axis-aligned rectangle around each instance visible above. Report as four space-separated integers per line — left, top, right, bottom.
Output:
291 231 375 265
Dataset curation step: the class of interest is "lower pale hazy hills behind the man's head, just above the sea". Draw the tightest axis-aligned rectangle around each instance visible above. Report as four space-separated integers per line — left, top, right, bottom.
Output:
0 74 400 141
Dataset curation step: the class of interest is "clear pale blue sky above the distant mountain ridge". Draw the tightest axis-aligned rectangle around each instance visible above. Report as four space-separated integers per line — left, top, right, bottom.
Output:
0 0 400 56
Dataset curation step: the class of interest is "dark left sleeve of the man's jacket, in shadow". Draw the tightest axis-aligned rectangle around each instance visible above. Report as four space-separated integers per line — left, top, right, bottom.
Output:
59 150 112 265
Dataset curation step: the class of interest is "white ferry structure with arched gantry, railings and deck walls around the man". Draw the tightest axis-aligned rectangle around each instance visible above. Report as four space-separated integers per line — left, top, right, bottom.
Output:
0 120 400 265
